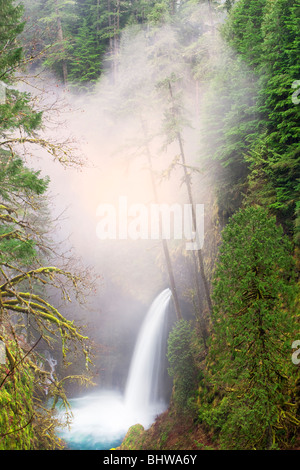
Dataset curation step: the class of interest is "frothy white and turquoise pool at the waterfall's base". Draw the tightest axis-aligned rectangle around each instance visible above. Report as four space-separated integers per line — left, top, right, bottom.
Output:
59 390 166 450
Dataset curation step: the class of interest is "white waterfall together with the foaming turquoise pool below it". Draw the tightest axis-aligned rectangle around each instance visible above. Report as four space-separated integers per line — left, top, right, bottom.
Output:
61 289 171 450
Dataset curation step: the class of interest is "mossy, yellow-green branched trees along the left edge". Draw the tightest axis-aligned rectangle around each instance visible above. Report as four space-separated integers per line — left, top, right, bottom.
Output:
0 0 89 450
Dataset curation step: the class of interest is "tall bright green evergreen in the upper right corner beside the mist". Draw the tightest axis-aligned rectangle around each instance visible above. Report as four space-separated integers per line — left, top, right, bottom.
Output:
224 0 300 242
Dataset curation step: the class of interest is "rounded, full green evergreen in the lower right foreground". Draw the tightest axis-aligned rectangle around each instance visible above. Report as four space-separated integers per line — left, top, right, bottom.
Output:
208 207 300 449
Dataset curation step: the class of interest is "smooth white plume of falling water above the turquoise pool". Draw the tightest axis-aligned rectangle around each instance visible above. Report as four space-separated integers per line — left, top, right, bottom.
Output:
125 289 171 424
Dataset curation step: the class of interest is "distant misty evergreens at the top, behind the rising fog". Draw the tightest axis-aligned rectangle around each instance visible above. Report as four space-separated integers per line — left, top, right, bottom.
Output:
23 0 179 90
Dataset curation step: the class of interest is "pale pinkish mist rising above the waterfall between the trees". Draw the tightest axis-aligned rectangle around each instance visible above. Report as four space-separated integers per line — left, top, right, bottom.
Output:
18 5 255 390
